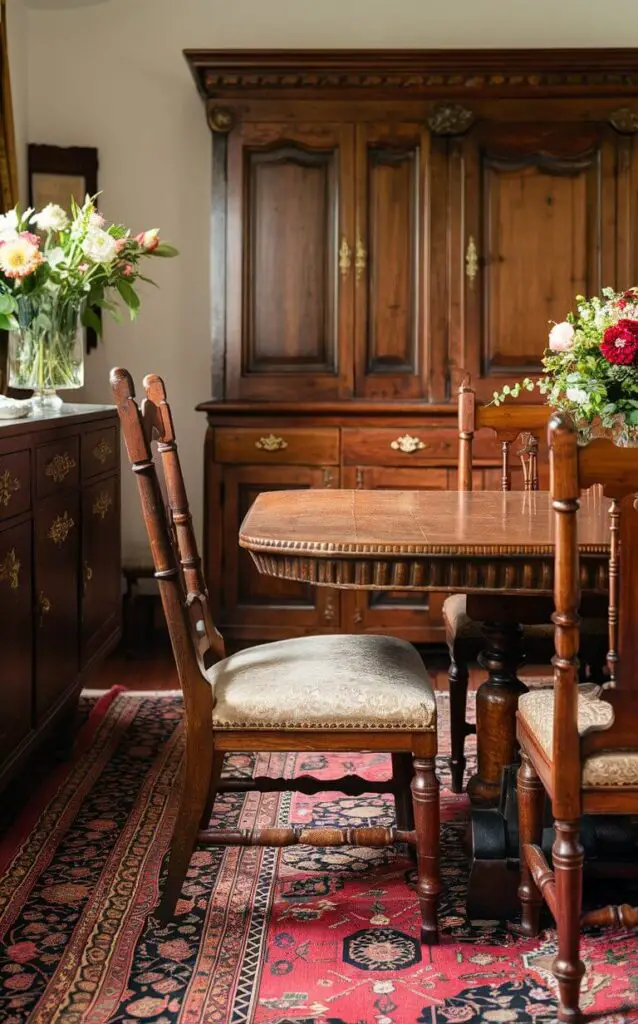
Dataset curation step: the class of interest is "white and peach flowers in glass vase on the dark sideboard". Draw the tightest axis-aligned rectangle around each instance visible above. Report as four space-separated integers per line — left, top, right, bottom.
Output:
0 196 177 408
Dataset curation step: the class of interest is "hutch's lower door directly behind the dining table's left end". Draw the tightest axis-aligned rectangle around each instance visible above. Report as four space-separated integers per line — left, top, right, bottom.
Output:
220 466 340 637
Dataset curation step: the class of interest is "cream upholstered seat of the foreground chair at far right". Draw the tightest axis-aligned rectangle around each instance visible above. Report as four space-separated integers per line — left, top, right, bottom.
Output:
518 683 638 787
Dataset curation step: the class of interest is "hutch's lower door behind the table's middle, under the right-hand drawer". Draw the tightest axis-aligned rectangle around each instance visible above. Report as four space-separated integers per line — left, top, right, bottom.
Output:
343 466 454 643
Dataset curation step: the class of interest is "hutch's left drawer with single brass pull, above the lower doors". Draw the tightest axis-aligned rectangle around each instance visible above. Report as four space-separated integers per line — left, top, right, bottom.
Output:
215 427 339 466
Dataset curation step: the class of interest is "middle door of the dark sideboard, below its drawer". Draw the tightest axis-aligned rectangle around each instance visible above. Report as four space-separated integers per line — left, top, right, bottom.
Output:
35 492 80 724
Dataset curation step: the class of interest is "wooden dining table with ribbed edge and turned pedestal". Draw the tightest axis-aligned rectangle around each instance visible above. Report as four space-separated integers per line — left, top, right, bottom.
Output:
240 489 610 921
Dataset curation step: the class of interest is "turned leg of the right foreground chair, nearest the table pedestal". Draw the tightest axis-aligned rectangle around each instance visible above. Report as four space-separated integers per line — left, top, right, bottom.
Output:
514 750 545 936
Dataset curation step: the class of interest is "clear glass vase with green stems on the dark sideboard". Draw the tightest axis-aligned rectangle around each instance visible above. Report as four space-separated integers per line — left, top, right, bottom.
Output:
9 295 84 409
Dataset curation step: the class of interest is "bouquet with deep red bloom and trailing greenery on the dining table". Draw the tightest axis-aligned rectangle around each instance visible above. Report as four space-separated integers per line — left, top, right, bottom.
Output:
493 288 638 446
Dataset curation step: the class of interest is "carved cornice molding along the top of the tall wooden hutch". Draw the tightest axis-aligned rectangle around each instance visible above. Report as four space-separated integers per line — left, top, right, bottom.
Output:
184 49 638 98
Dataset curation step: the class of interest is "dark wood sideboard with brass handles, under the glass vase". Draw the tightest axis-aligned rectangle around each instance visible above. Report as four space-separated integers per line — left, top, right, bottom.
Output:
0 406 122 786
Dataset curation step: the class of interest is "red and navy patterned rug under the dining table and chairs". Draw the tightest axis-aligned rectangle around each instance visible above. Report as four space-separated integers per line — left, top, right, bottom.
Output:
0 688 638 1024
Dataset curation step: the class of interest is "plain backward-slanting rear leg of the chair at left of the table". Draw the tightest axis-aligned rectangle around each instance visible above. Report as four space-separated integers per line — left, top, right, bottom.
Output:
157 724 213 924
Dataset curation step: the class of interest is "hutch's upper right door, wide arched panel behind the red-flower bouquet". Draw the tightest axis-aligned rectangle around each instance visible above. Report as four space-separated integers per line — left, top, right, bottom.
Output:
446 122 619 399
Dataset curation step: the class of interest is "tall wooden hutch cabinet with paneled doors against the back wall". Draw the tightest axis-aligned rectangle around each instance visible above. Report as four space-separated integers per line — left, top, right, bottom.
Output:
186 50 638 643
